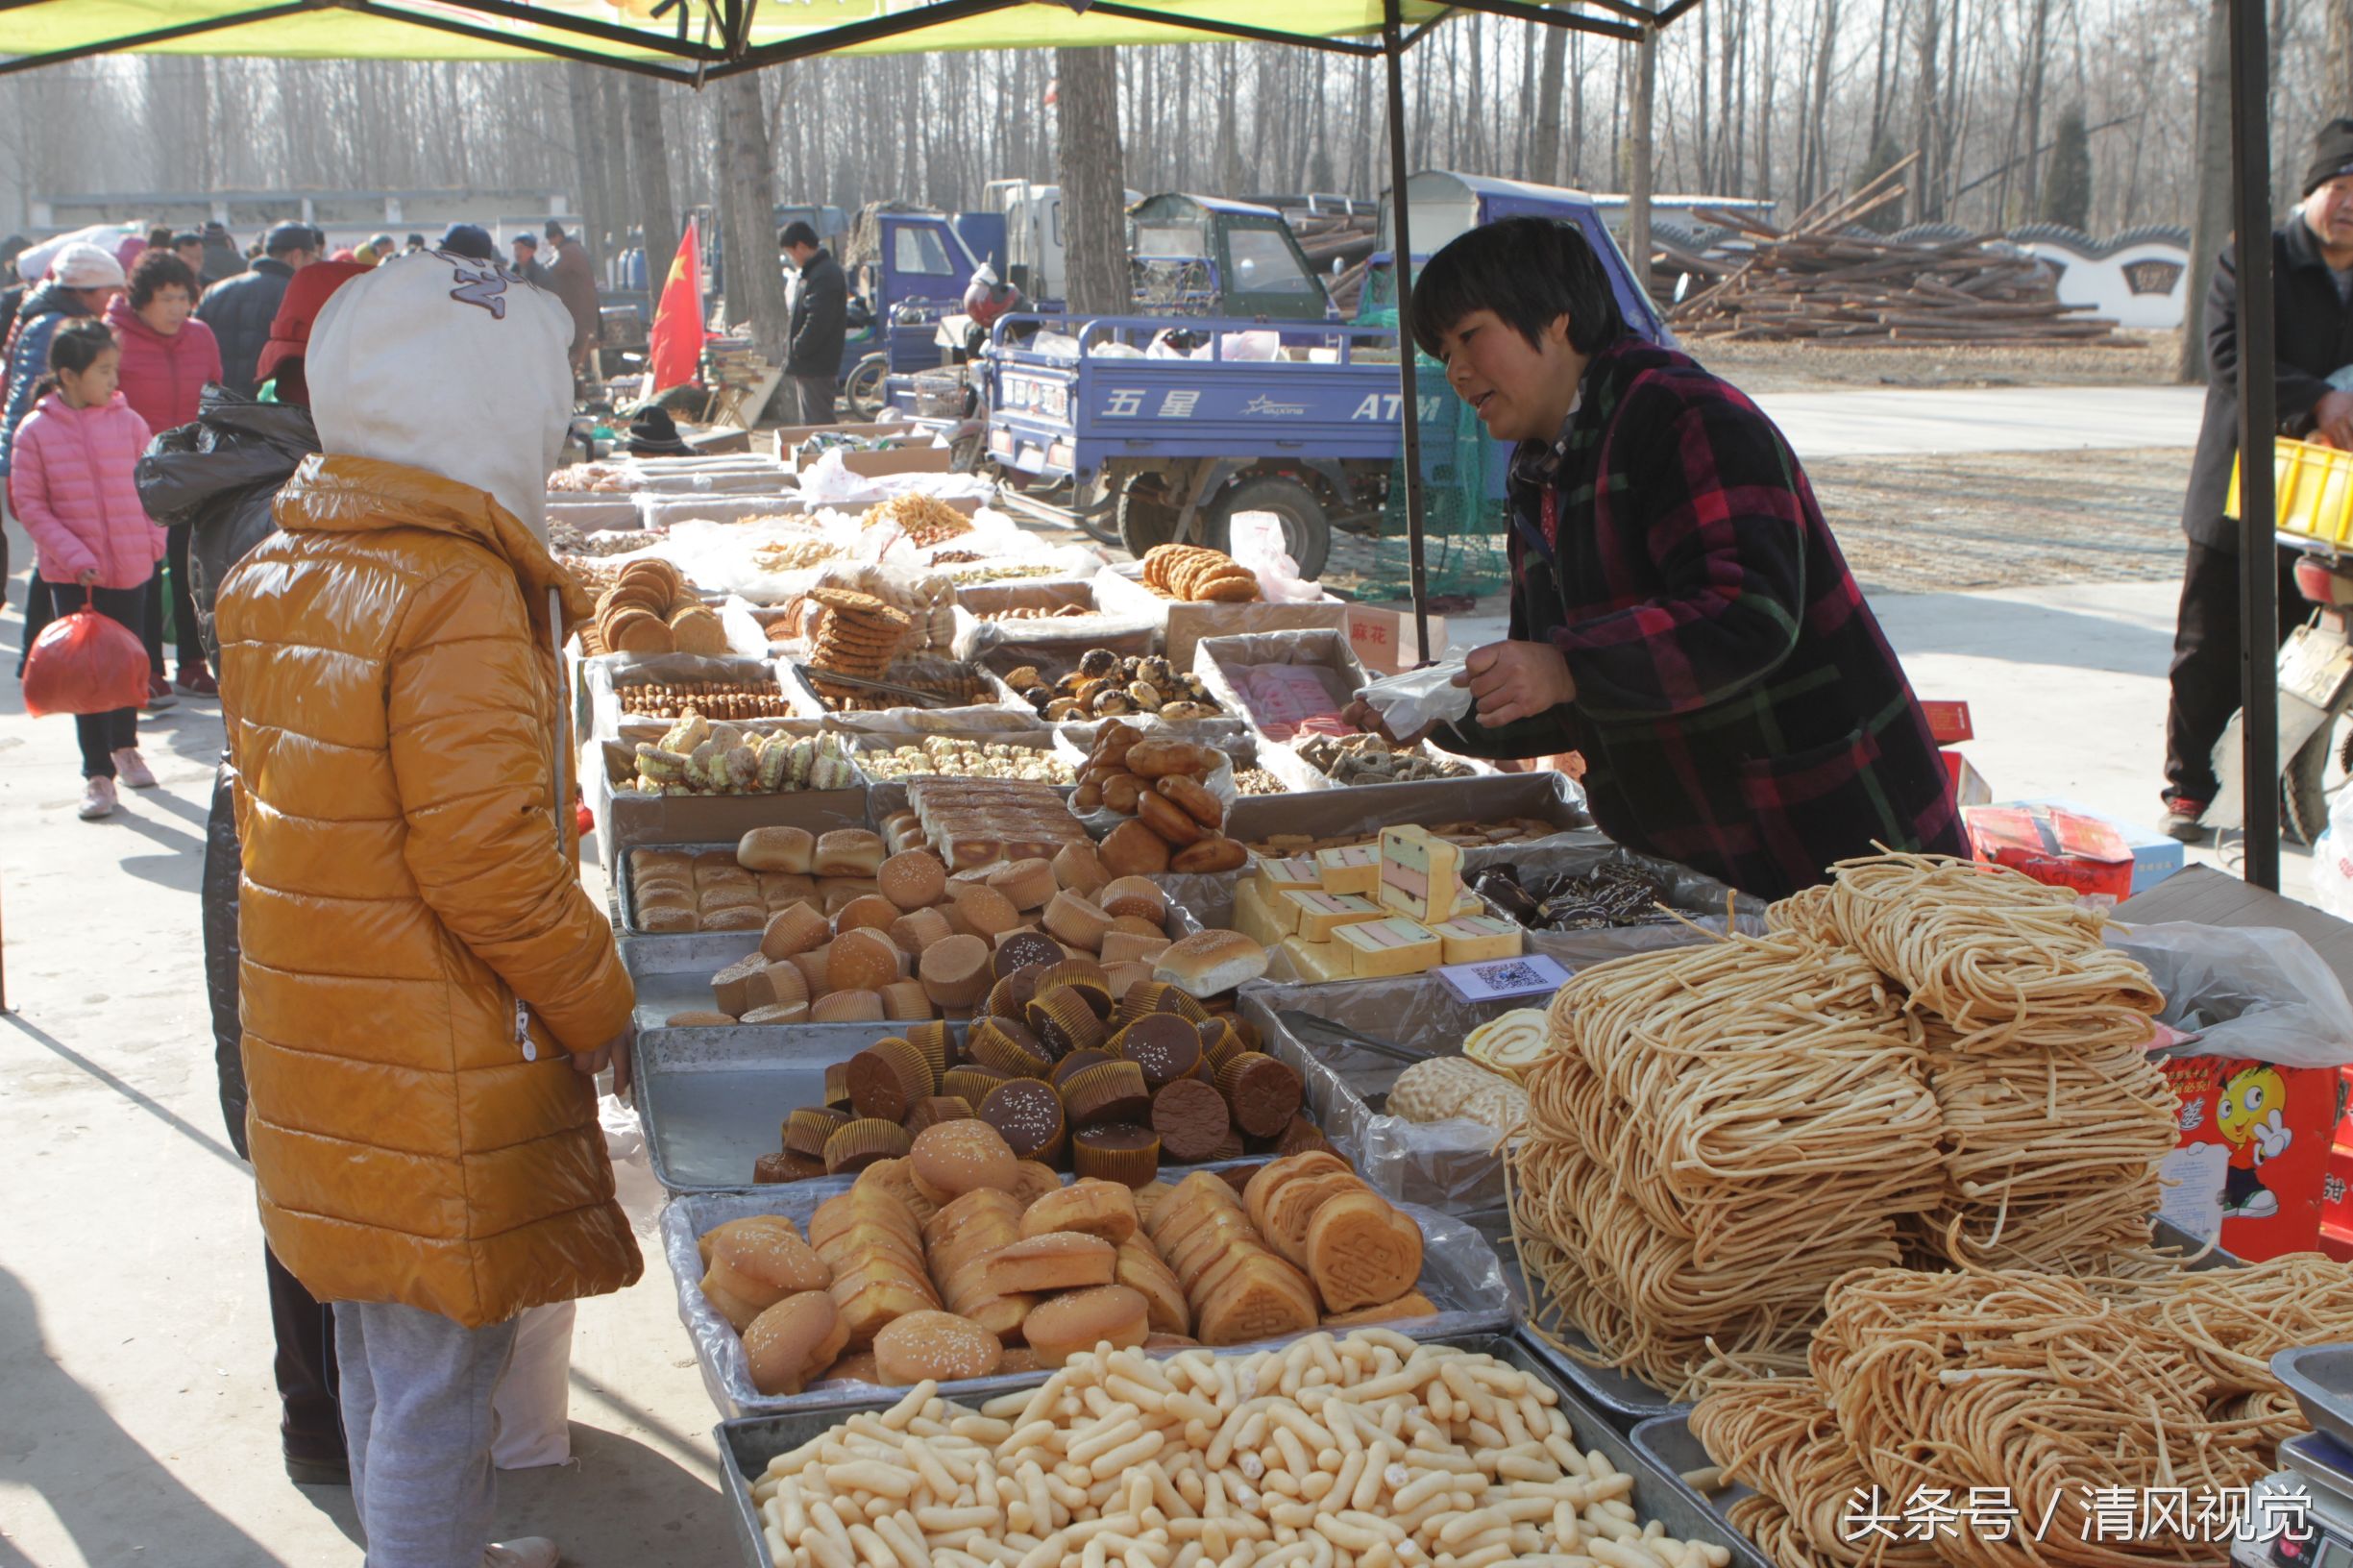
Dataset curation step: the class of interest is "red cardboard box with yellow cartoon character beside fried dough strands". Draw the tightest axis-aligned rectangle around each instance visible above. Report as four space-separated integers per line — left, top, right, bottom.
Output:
2158 1057 2343 1262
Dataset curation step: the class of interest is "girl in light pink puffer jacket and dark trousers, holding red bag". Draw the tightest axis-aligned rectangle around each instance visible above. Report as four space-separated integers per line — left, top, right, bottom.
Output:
7 320 164 821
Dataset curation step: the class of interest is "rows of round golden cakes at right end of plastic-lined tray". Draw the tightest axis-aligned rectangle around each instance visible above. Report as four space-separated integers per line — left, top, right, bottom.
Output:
1146 1149 1435 1344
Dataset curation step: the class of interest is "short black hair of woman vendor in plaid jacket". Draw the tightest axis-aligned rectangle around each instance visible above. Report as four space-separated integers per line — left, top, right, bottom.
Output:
1411 216 1626 357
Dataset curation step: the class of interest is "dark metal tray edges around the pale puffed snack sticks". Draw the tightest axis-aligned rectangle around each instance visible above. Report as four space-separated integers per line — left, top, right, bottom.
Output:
713 1335 1770 1568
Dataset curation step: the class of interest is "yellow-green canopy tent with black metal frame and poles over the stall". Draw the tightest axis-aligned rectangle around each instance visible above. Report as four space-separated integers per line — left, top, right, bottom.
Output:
0 0 2285 888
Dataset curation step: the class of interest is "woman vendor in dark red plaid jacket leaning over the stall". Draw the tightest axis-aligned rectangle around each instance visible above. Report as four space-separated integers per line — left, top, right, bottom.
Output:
1351 216 1970 899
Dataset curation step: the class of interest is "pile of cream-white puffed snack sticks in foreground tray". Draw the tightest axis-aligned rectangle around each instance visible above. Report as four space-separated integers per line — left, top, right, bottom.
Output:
753 1328 1731 1568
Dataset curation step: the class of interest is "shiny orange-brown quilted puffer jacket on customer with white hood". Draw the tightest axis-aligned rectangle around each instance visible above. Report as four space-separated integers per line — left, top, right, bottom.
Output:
216 456 643 1328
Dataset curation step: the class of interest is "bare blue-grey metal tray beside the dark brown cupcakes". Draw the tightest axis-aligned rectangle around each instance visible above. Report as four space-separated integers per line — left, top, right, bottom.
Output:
630 1021 960 1193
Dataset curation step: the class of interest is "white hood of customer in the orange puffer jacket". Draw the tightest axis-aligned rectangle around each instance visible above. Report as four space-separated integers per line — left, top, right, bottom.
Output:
304 250 572 542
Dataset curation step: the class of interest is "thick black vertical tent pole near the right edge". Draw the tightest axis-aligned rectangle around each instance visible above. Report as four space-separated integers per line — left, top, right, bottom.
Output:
2231 0 2280 893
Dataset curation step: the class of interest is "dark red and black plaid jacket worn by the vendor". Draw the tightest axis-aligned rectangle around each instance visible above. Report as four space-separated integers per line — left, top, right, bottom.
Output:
1435 339 1967 897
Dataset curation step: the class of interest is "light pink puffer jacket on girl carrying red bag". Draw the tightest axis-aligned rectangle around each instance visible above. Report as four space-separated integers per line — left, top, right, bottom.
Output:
7 393 162 589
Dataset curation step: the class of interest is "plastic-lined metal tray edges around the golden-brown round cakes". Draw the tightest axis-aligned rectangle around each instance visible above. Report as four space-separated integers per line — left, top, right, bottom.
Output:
661 1187 1513 1415
